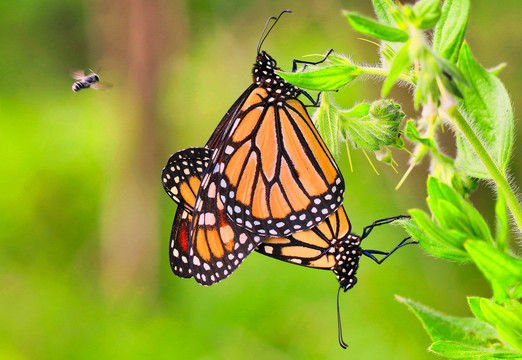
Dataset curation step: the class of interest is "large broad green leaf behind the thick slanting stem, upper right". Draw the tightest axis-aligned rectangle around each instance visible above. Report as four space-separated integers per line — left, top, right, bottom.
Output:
457 43 513 179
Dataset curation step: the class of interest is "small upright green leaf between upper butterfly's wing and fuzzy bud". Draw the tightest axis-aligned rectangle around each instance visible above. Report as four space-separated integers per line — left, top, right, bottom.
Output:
313 92 341 156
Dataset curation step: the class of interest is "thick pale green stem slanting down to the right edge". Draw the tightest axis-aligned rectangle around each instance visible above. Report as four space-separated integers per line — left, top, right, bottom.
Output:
448 107 522 232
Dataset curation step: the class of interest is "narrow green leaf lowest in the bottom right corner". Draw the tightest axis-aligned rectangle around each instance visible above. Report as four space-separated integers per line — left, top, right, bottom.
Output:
428 341 521 359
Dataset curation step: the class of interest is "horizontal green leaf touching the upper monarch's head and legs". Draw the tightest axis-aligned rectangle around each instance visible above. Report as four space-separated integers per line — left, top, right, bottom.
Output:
277 65 361 91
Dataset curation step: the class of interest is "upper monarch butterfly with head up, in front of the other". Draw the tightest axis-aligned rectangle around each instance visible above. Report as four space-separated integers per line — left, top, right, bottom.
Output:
162 10 344 285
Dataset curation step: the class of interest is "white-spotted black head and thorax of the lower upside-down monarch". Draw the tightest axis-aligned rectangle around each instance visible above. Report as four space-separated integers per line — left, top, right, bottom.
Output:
333 234 363 292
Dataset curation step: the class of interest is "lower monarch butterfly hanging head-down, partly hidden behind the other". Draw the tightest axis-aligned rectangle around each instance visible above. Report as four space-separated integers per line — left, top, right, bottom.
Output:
163 148 416 348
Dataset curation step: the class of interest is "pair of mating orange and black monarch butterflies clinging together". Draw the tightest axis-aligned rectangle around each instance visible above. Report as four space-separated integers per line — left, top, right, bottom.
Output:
162 12 407 291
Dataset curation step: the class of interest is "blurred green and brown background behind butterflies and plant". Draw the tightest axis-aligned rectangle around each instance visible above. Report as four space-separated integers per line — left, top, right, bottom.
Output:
0 0 522 360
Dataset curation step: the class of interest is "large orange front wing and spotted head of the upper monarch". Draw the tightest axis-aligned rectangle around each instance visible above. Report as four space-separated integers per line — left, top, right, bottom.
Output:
205 52 344 236
